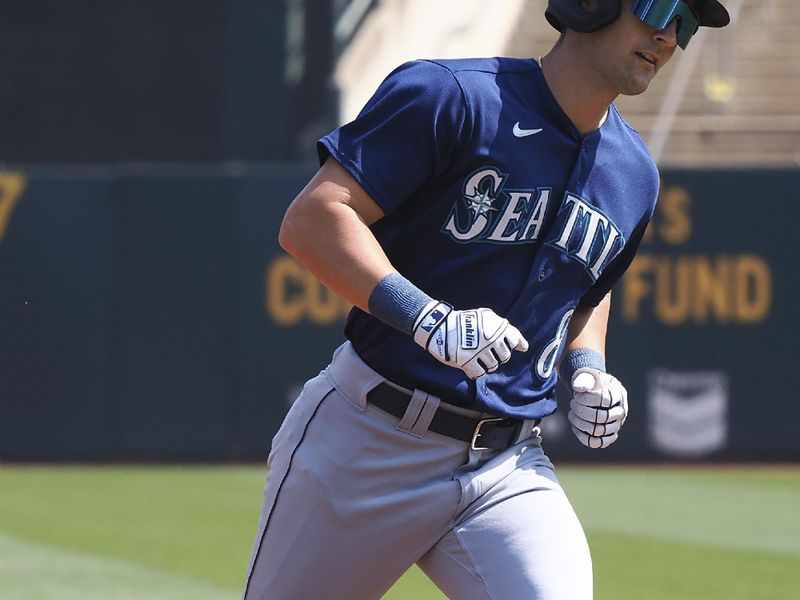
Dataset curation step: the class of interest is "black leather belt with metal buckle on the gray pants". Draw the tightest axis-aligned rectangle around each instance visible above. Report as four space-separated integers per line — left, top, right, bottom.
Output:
367 383 536 450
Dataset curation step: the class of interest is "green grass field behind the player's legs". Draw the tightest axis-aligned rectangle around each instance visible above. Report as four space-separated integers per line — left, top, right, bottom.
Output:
0 466 800 600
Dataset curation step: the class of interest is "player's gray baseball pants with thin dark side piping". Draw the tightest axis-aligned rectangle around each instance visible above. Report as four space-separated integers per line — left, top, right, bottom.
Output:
243 343 592 600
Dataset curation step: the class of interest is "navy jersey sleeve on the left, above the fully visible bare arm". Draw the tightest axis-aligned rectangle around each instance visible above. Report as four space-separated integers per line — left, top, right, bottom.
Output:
317 61 467 214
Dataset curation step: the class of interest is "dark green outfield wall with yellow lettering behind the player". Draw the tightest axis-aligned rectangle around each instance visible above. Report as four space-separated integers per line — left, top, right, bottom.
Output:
0 164 800 461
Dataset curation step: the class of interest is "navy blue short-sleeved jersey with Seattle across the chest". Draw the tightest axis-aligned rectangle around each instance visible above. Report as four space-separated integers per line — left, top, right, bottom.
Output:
318 58 659 418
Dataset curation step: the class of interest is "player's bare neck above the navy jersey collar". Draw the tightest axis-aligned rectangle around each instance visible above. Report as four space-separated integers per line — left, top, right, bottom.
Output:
539 46 618 135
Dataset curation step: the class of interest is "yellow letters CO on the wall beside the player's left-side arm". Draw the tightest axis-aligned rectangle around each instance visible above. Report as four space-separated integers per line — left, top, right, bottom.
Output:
265 256 351 327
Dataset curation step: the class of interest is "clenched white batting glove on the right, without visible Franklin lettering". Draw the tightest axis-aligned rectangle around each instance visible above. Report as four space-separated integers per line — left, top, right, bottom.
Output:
567 367 628 448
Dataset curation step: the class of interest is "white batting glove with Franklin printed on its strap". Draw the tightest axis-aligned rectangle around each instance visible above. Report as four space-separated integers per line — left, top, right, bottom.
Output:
414 300 528 379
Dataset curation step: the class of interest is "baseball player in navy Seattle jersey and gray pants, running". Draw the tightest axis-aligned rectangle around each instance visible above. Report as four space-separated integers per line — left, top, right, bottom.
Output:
244 0 729 600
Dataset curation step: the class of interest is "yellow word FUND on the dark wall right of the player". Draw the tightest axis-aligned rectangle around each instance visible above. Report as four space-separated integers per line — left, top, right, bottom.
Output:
621 254 772 326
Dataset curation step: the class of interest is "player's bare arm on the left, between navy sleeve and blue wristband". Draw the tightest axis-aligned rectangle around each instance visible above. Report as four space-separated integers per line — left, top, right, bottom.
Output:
278 158 395 311
